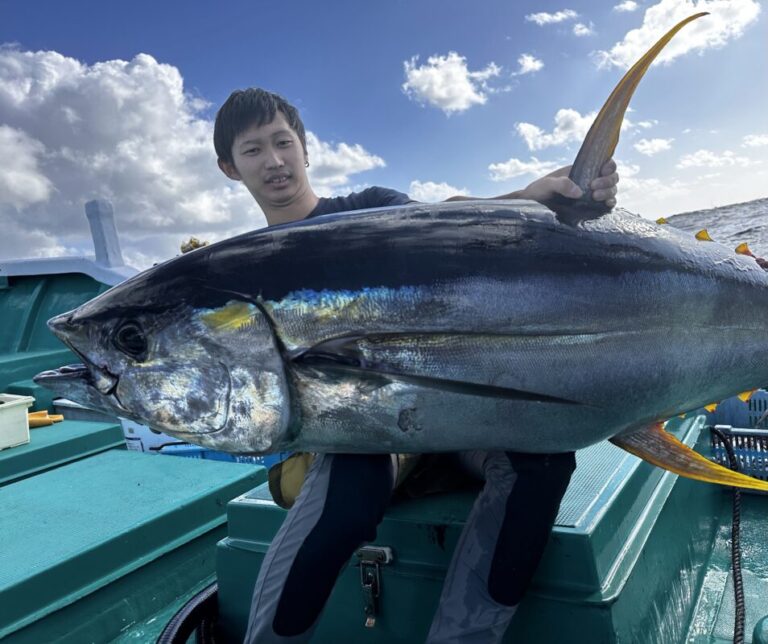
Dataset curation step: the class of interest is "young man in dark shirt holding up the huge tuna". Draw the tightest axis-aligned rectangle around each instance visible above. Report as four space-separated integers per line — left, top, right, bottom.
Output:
214 89 618 644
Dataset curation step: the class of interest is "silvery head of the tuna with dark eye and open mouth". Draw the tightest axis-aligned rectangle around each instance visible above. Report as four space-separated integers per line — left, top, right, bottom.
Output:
35 266 290 453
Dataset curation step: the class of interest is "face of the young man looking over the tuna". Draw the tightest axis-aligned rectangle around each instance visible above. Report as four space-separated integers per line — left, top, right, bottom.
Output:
222 111 309 209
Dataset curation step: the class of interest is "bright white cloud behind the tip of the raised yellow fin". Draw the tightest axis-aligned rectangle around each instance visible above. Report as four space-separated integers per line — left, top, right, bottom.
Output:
596 0 760 69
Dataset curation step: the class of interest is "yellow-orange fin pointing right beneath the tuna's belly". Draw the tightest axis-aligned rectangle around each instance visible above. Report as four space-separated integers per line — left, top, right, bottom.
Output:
611 423 768 491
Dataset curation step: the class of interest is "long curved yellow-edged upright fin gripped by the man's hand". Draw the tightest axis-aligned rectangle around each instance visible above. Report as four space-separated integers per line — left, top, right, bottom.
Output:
547 12 707 225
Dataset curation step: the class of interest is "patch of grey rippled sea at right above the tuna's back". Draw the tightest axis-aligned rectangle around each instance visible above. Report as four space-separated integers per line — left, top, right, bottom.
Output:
667 197 768 258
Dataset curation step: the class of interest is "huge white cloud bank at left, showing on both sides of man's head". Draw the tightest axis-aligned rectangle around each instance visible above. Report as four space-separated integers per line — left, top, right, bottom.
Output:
0 47 383 267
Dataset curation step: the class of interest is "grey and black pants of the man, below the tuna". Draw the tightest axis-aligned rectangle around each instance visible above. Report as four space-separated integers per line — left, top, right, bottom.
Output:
245 452 574 644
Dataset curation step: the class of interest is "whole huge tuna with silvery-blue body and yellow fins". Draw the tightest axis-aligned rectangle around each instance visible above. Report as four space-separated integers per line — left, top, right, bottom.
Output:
37 13 768 488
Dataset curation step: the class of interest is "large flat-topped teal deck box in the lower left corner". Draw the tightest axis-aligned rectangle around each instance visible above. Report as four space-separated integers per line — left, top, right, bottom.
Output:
0 428 266 644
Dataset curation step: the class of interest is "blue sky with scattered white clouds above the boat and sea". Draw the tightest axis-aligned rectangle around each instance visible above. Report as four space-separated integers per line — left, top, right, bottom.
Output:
0 0 768 267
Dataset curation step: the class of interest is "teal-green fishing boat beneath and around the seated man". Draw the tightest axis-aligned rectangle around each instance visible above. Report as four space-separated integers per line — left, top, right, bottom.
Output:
0 202 768 644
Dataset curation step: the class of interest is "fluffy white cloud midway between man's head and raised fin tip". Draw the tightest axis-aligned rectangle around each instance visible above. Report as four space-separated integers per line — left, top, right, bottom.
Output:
402 51 501 114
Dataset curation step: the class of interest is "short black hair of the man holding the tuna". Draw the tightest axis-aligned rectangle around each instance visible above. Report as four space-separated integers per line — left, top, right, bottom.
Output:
213 87 307 163
